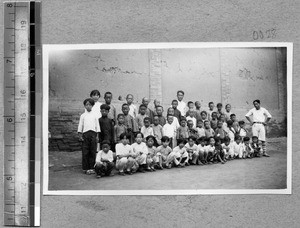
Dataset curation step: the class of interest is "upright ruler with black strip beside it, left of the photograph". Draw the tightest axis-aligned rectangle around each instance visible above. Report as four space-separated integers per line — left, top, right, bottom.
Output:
4 1 42 226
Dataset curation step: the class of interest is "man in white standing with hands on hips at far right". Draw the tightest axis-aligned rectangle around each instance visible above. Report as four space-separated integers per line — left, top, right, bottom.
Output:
245 100 272 157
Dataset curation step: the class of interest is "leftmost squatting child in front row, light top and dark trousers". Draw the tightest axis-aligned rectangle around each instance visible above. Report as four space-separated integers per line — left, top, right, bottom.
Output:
95 140 115 178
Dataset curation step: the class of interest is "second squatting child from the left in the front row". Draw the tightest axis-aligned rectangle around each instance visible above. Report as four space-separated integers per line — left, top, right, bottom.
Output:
116 133 135 176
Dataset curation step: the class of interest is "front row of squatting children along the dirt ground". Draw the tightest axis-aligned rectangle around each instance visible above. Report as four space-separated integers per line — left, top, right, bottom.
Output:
92 132 261 178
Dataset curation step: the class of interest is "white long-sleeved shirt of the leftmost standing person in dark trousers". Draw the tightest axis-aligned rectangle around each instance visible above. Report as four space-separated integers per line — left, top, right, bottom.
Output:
77 111 101 133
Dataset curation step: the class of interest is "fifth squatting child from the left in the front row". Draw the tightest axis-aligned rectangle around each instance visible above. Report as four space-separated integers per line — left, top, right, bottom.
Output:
156 136 174 169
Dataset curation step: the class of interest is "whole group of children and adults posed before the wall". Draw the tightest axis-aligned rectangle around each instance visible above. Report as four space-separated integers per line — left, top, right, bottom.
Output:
78 90 272 178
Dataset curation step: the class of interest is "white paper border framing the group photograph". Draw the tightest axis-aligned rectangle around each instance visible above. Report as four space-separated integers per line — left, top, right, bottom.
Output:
42 42 293 195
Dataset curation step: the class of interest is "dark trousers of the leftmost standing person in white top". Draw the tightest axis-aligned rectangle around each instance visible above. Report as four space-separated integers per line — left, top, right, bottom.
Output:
82 131 97 170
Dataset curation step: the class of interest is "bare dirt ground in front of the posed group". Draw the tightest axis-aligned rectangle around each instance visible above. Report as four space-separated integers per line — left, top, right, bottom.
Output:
48 138 287 190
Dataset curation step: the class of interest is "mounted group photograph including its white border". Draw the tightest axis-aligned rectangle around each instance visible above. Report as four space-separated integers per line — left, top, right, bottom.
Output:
43 42 292 195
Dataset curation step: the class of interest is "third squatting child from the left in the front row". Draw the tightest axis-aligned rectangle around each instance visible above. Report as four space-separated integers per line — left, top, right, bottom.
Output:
131 132 149 173
